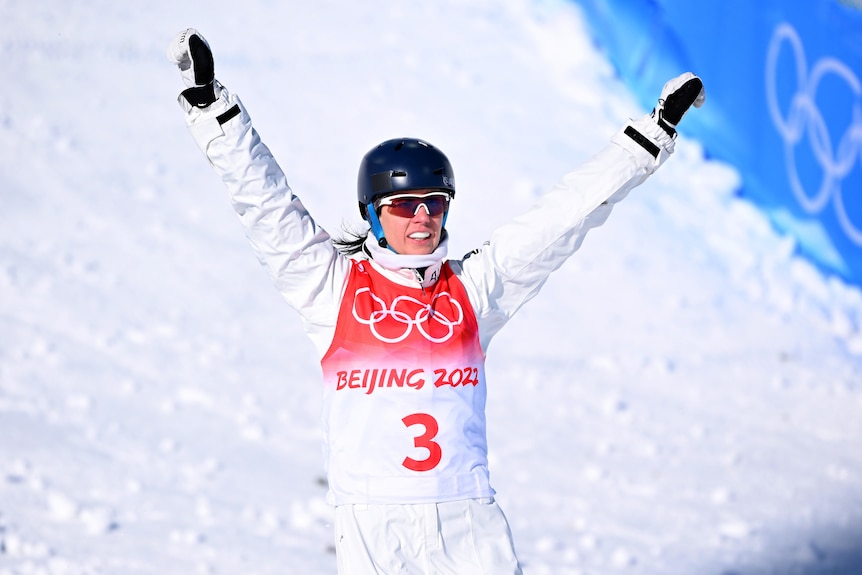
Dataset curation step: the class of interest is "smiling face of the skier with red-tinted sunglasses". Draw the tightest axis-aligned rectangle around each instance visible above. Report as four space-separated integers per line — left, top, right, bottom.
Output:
380 190 449 255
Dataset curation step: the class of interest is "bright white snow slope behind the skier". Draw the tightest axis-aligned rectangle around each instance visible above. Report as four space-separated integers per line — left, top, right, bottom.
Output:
0 0 862 575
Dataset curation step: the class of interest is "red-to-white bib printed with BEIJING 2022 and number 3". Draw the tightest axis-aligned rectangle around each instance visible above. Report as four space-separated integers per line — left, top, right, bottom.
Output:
321 260 493 505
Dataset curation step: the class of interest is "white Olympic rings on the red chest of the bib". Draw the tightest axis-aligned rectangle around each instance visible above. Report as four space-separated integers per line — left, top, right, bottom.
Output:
353 287 464 343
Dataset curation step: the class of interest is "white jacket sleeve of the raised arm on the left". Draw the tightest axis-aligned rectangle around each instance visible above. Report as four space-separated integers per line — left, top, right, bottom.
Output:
179 85 349 357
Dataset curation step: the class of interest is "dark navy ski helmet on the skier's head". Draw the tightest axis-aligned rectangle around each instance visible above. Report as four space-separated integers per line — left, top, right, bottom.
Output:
358 138 455 220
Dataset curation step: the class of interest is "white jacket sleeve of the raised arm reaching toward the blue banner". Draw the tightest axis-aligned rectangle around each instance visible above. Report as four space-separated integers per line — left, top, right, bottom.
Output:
452 116 675 351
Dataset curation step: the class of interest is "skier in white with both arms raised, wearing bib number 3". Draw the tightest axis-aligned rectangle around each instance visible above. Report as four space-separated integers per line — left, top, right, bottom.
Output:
168 28 704 575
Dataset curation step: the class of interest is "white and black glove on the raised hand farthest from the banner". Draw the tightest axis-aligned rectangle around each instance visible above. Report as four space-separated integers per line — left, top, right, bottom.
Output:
168 28 216 108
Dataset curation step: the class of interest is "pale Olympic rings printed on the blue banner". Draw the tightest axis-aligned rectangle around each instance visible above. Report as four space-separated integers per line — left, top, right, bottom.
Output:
766 24 862 246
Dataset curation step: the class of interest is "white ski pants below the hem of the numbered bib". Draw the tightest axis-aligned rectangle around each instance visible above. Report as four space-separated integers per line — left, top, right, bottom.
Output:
335 498 521 575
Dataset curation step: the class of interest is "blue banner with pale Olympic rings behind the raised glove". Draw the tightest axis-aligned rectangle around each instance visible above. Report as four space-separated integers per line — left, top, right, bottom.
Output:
576 0 862 285
